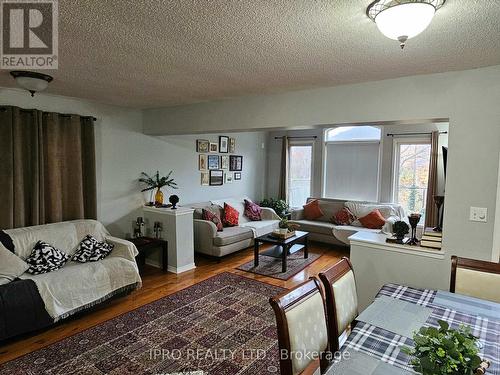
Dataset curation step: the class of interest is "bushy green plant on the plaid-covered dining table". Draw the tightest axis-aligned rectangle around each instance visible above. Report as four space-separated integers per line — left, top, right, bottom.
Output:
401 320 481 375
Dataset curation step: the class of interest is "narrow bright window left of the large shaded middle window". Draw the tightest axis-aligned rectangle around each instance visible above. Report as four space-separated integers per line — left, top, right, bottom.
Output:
288 143 313 207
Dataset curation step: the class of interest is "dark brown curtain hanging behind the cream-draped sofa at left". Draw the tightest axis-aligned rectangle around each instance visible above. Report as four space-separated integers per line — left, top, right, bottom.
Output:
0 107 97 229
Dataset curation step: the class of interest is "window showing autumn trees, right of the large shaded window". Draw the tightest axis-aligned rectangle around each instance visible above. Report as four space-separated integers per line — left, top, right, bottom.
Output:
393 139 431 225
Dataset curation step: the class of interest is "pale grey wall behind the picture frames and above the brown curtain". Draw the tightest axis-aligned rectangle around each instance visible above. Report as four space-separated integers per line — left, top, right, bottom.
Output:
0 88 266 236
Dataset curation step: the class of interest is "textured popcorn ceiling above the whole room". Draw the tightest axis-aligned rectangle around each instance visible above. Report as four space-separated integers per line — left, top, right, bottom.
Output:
0 0 500 108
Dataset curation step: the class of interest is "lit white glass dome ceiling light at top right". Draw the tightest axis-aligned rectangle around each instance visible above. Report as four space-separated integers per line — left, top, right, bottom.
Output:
366 0 446 49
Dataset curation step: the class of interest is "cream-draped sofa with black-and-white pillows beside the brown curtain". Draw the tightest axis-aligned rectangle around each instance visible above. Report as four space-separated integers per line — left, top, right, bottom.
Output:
4 220 141 322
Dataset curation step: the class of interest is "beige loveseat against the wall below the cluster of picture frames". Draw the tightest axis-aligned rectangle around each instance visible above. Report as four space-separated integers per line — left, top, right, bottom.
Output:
191 198 280 258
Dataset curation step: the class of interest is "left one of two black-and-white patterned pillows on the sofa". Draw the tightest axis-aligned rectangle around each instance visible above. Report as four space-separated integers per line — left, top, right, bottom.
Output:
26 241 69 275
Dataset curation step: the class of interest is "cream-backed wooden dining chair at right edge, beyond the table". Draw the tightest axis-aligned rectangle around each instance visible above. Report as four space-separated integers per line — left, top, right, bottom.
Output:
450 255 500 302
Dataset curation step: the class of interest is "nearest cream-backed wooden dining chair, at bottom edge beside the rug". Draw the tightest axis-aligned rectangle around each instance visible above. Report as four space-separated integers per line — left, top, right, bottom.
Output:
269 278 328 375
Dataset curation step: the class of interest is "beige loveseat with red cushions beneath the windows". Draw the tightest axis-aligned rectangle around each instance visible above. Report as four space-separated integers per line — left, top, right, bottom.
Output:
290 198 406 246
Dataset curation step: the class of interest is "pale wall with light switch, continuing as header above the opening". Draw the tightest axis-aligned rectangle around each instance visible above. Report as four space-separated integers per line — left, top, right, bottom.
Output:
144 66 500 278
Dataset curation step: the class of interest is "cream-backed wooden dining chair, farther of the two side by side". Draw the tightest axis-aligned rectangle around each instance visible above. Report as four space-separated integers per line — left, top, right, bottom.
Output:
319 257 358 352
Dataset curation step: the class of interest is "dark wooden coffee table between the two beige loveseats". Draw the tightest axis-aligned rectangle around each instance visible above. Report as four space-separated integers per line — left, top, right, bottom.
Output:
253 230 309 272
